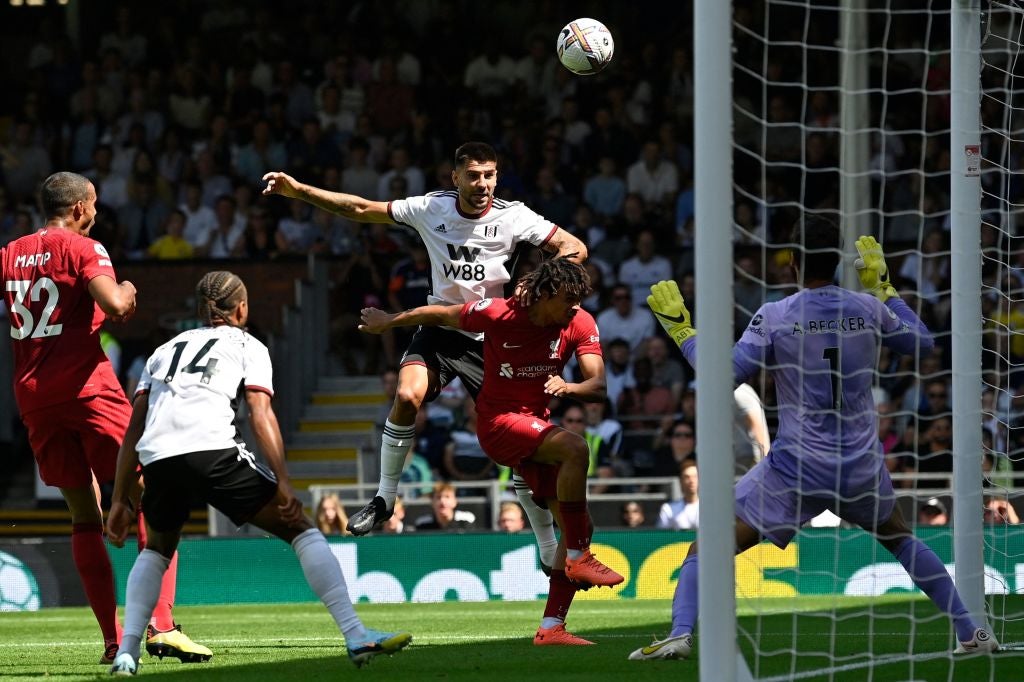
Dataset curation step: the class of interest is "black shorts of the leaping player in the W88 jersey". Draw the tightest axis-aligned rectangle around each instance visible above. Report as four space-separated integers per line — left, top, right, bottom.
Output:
401 327 483 401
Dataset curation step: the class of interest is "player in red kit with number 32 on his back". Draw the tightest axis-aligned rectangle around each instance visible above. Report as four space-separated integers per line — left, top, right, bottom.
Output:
0 171 213 664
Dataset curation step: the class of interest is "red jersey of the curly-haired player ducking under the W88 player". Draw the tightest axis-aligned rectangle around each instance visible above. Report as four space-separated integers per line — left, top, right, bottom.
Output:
461 298 601 418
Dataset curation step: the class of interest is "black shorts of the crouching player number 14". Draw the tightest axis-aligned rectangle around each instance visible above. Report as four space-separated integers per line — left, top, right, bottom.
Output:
142 444 278 532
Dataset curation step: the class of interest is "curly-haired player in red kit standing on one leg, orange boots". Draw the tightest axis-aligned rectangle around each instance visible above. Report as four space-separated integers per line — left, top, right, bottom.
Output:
359 256 623 645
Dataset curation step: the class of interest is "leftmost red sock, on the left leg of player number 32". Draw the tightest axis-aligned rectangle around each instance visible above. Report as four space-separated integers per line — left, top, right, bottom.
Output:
71 523 121 644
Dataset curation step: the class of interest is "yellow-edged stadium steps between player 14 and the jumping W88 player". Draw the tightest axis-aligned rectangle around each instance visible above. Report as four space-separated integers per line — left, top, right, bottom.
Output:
287 377 386 489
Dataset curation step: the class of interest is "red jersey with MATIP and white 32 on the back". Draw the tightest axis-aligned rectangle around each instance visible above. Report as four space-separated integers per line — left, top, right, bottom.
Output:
0 228 122 414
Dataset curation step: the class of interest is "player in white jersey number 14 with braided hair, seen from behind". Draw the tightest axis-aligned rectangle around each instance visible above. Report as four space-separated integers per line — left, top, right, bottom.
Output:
106 271 412 676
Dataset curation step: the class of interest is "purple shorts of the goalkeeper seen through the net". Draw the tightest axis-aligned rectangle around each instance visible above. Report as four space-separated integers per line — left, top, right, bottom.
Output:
736 455 896 548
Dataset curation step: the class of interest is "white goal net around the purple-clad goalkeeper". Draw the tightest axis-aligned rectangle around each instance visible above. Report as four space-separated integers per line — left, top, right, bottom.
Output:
708 0 1024 680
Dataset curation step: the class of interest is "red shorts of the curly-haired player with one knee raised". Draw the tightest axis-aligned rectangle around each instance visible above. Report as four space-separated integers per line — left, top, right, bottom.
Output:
476 412 558 500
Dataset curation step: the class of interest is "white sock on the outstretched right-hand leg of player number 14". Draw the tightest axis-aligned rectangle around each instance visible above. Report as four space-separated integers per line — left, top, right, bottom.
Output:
292 528 367 643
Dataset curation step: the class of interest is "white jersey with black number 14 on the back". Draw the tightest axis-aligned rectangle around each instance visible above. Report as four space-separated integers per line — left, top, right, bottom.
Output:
135 325 273 465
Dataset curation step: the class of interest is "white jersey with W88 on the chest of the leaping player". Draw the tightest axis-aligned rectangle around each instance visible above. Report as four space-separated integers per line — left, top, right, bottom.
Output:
387 189 558 303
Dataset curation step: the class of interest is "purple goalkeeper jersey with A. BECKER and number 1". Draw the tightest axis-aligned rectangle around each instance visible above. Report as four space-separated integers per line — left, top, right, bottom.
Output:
683 286 934 494
